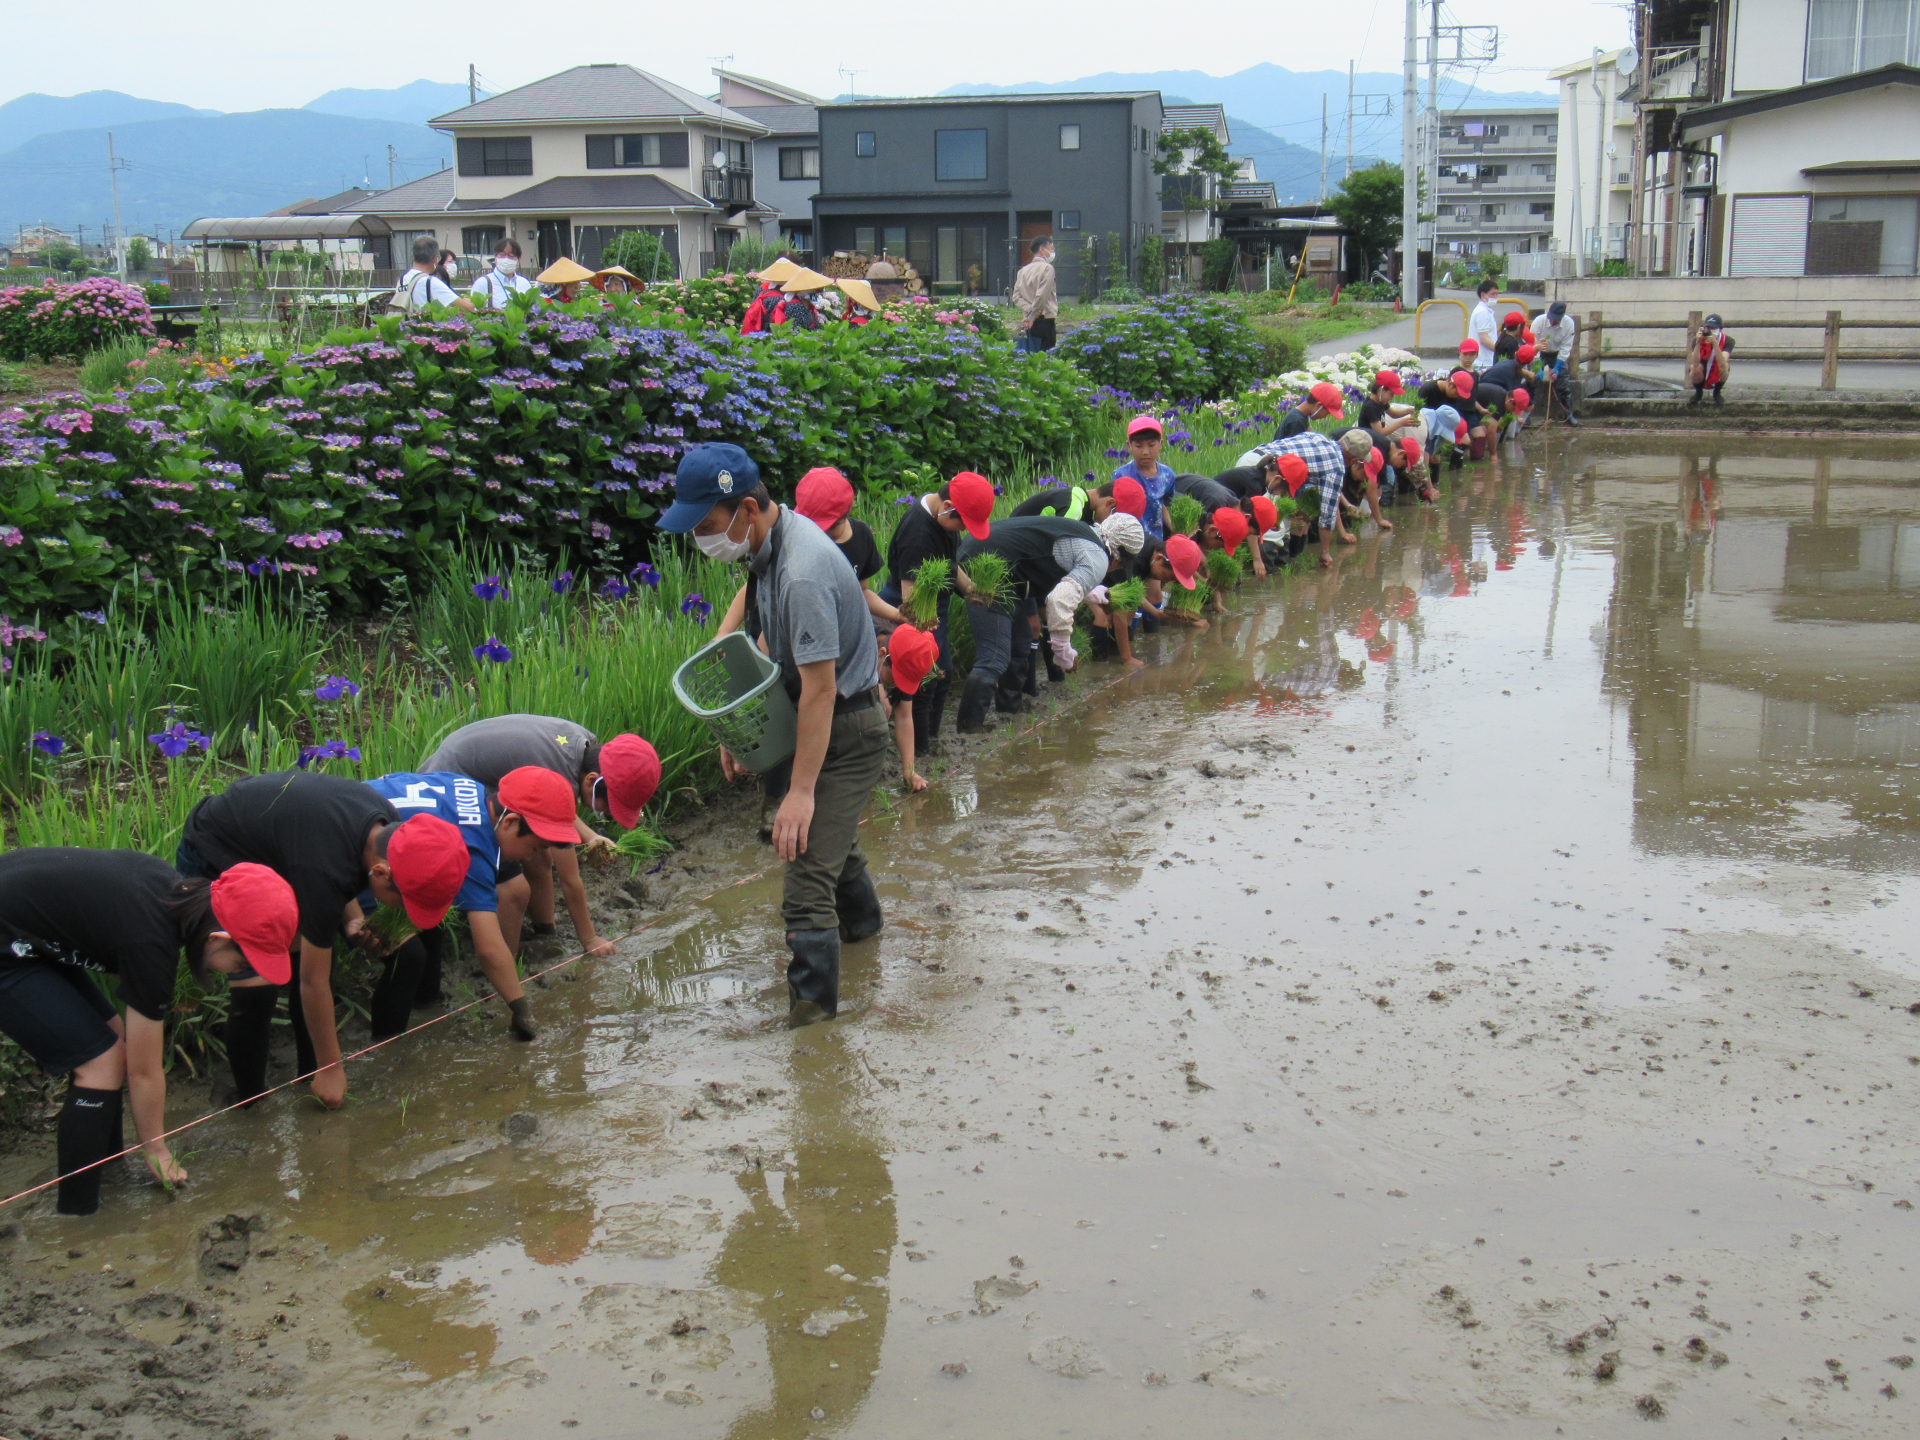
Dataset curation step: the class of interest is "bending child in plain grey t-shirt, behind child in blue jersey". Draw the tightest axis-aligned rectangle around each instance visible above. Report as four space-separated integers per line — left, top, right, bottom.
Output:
420 714 660 954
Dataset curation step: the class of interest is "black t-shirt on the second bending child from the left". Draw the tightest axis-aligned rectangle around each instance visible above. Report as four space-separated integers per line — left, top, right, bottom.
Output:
180 770 399 948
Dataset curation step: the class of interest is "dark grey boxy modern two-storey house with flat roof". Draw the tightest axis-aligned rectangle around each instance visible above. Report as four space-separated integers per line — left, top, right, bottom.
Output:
814 90 1162 296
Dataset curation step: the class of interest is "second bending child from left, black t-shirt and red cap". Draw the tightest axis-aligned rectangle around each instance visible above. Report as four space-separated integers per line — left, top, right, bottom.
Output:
173 770 467 1110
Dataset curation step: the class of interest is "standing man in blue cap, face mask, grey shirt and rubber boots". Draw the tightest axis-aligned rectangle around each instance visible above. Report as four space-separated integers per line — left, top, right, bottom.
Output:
660 445 889 1025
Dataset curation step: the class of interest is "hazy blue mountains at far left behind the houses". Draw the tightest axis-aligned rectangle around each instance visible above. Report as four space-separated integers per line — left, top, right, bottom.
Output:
0 81 478 242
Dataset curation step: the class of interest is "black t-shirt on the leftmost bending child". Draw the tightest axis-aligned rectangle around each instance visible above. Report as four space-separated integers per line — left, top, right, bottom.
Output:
0 844 183 1020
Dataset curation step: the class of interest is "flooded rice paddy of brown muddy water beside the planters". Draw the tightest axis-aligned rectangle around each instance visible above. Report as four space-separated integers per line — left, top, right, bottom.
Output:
12 438 1920 1440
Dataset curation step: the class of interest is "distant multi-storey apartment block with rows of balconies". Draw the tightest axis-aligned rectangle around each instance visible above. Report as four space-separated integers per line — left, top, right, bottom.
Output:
1432 109 1559 255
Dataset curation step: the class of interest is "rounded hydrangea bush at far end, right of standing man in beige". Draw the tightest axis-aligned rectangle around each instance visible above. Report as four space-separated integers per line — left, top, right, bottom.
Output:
1058 296 1263 399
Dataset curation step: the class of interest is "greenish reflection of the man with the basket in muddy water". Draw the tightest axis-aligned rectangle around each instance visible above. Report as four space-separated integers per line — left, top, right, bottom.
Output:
714 1035 899 1440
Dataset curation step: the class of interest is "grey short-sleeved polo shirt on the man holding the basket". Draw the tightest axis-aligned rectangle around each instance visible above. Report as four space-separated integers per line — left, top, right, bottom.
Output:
749 505 879 695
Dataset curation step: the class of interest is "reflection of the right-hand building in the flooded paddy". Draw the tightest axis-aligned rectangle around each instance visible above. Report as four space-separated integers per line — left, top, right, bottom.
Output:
1605 457 1920 868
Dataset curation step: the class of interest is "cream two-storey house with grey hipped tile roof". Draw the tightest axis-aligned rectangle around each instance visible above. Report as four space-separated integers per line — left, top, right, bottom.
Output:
334 65 768 275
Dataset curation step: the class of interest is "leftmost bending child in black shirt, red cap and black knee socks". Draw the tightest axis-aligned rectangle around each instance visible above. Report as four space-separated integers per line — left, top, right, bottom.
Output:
0 849 300 1215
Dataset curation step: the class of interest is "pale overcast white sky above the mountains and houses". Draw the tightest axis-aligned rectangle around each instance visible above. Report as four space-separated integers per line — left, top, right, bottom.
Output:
0 0 1626 123
